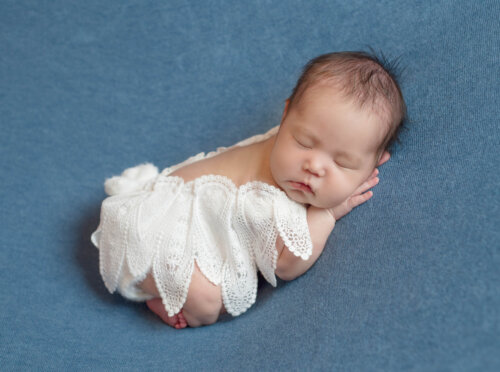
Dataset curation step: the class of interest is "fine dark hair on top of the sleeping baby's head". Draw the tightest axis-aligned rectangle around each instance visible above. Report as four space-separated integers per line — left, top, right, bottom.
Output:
289 48 407 150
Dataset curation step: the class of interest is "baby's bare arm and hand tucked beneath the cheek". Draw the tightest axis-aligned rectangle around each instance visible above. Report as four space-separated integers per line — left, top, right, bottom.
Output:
275 169 379 280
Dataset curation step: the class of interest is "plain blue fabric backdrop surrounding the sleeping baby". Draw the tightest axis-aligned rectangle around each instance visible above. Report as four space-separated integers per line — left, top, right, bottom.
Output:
0 0 500 371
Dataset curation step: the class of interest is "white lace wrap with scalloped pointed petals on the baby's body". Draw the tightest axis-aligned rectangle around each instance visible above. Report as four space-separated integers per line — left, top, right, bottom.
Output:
91 127 312 316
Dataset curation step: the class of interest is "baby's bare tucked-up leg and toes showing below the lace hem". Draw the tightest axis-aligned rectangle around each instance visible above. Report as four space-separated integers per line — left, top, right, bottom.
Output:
140 262 226 329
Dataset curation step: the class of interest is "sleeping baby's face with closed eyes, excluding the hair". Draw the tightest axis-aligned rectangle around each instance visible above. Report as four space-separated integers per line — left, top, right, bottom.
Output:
270 85 385 208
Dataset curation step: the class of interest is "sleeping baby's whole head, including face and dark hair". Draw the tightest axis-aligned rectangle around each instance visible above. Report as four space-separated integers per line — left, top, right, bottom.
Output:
271 52 406 208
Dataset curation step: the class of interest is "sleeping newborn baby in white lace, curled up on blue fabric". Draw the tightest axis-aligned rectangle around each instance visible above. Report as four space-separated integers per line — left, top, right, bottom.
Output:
92 52 406 329
